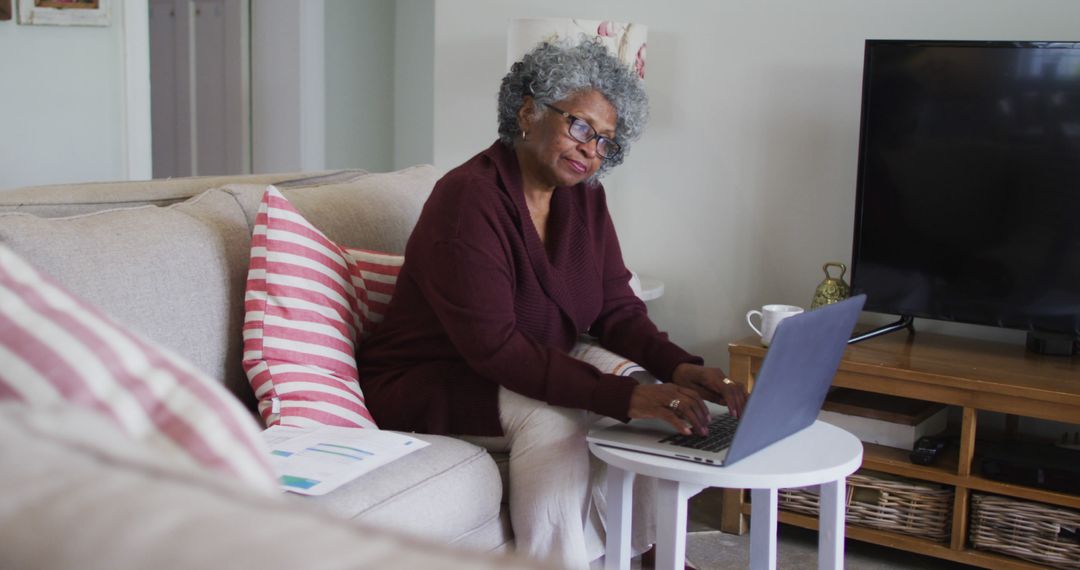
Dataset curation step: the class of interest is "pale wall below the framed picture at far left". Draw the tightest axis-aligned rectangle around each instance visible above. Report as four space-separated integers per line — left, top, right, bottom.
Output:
0 2 127 189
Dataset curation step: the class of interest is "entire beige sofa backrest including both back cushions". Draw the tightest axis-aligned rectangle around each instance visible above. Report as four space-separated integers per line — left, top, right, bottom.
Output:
0 165 438 407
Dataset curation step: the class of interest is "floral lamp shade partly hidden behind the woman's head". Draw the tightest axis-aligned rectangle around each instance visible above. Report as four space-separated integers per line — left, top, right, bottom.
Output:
507 18 648 79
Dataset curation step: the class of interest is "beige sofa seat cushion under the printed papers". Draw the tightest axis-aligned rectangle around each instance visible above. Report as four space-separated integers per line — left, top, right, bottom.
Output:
305 433 502 542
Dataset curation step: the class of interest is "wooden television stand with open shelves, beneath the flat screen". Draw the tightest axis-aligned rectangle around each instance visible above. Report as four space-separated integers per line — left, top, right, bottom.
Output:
721 333 1080 569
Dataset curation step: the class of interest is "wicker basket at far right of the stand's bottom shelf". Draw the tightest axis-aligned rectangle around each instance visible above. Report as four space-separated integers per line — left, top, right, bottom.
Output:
969 493 1080 569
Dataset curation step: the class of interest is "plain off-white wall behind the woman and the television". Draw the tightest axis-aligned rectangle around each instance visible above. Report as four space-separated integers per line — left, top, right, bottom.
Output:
423 0 1080 366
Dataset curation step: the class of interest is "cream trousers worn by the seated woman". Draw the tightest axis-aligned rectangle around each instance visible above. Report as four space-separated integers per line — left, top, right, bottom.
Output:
461 386 657 569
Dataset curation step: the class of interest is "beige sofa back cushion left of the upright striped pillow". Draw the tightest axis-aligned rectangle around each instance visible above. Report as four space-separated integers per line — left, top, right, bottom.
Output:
0 190 254 406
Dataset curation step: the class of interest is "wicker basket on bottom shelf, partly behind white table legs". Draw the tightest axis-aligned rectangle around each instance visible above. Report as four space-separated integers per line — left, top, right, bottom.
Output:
779 471 953 542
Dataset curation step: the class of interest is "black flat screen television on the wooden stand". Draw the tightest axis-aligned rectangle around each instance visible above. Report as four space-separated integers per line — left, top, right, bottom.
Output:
851 40 1080 352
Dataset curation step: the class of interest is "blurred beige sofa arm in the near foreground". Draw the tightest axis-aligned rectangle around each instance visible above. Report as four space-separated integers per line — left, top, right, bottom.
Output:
0 403 541 570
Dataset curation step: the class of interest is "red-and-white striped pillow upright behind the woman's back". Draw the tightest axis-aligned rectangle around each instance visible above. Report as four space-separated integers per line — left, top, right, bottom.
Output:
244 186 404 428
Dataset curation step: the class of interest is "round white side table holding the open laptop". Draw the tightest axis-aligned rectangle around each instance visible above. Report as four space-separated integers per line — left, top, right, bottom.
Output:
589 421 863 570
